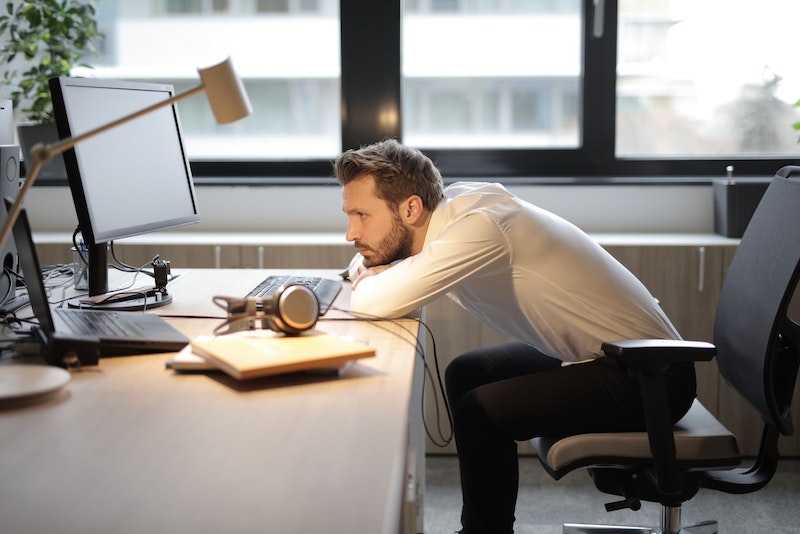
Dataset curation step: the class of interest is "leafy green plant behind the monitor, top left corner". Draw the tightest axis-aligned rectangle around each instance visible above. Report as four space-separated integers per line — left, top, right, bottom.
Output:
0 0 102 123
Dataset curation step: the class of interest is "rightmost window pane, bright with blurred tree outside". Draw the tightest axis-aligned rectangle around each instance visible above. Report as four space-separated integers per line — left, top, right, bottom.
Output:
616 0 800 157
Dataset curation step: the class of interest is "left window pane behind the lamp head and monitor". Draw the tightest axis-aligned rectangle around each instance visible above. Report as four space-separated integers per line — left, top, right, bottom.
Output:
86 0 341 161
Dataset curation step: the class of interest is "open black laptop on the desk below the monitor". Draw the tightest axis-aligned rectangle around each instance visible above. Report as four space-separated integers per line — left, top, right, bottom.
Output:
6 205 189 356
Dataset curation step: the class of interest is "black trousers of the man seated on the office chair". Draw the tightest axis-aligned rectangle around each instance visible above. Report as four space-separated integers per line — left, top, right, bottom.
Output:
445 343 696 534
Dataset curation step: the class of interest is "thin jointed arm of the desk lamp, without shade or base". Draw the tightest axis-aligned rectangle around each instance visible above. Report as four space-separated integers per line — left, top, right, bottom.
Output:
0 84 205 251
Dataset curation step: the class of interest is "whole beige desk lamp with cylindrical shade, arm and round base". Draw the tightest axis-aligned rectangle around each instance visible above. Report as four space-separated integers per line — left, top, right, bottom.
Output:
0 58 252 402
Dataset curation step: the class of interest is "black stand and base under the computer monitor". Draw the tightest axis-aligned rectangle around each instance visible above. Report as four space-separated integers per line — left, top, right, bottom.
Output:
67 243 172 311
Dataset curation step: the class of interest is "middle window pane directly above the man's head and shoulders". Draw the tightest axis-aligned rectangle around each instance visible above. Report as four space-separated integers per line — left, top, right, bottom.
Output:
402 0 582 149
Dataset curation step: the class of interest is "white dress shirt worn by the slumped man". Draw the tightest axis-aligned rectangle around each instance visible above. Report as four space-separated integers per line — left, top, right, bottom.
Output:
350 182 680 362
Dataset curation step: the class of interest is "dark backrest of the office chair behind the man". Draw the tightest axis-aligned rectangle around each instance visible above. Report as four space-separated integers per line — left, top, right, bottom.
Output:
714 167 800 434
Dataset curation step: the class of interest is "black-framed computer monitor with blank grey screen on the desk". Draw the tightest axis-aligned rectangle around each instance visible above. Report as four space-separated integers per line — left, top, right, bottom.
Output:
50 77 200 309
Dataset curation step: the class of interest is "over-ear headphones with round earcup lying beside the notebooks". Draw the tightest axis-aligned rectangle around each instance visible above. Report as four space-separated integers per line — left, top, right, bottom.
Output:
213 284 319 336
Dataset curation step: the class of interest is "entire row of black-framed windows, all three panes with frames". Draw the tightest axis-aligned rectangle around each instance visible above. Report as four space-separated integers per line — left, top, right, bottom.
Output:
50 0 800 179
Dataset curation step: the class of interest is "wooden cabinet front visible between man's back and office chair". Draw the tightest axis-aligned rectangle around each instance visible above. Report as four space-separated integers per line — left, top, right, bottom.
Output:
606 246 723 414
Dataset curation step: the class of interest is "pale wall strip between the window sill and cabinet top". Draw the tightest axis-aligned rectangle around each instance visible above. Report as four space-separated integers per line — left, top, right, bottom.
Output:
26 185 714 233
